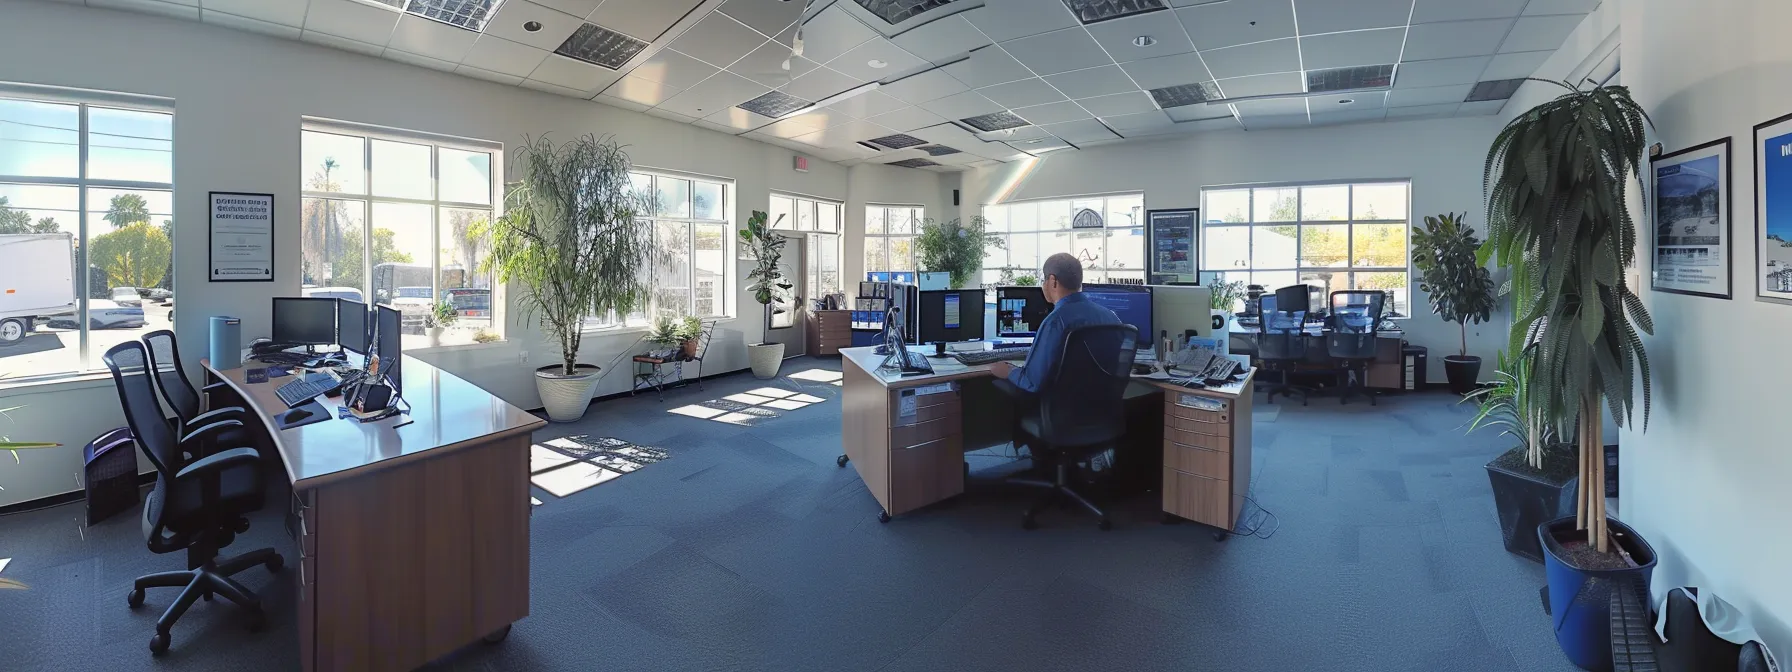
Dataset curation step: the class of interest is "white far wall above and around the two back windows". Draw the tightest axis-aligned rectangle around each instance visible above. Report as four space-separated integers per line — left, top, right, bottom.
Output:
962 116 1511 382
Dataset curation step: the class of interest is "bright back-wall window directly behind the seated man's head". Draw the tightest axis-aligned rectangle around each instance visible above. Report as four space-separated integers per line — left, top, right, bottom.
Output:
984 194 1145 285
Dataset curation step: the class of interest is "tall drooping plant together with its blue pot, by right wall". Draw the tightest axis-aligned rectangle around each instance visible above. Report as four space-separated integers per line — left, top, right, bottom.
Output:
1486 82 1656 668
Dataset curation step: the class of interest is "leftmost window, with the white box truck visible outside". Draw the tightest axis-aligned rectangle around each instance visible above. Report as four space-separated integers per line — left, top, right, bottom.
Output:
0 84 172 382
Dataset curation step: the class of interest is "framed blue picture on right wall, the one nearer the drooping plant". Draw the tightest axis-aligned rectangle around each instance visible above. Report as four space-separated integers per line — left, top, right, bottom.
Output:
1650 138 1733 299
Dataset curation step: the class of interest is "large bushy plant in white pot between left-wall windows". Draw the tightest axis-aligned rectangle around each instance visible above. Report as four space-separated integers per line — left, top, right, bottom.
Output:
480 134 654 423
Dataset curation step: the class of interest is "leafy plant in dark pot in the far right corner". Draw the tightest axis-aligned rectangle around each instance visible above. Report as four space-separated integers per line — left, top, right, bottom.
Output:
1412 213 1495 394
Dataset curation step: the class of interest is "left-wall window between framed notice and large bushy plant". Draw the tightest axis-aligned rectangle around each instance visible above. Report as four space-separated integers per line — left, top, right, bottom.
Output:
299 122 504 348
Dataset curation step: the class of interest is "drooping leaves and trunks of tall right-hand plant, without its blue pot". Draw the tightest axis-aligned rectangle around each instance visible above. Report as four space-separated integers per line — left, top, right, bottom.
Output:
1484 82 1654 552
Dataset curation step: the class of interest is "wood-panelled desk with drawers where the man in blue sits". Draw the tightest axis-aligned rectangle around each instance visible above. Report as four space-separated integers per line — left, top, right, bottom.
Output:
840 348 1256 530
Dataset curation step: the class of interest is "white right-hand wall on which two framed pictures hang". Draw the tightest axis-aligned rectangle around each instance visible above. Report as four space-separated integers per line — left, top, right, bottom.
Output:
1607 0 1792 661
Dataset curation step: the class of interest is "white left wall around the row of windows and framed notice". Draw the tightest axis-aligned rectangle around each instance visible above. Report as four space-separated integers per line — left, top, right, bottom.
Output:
0 0 950 505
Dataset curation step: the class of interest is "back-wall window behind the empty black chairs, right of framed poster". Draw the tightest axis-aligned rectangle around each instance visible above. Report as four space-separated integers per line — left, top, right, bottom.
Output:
1201 181 1410 314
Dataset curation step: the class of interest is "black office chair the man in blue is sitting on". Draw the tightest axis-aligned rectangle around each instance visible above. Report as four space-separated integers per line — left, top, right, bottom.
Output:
1009 324 1138 530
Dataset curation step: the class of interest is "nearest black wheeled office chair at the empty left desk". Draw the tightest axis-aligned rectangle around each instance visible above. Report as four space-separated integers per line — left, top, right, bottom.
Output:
106 340 285 654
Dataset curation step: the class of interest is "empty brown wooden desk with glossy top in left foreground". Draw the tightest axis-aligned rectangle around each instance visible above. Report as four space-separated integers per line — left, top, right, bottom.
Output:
202 357 547 672
